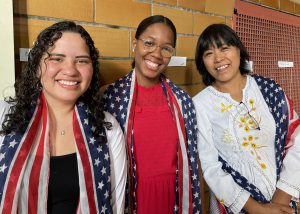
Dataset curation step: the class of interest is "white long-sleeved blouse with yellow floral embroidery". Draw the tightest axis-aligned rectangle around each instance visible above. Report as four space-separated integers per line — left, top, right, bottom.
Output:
193 76 300 213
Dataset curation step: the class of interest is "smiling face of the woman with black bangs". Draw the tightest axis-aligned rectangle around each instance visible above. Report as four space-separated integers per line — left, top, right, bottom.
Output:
203 44 242 85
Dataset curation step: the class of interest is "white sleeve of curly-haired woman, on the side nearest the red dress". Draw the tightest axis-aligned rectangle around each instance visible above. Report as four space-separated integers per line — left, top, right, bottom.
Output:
105 112 127 213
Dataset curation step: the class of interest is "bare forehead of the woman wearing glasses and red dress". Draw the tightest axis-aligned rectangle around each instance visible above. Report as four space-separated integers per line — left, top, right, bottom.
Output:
141 23 174 44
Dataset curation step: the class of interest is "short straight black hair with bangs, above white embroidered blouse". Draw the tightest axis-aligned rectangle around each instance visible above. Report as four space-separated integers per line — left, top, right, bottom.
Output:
195 24 250 85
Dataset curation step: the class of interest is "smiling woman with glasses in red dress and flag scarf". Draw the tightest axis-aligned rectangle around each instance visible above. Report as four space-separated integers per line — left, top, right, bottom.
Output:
104 15 201 214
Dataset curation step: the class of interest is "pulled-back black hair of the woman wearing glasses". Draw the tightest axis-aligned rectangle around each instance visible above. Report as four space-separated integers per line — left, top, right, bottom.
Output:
132 15 177 68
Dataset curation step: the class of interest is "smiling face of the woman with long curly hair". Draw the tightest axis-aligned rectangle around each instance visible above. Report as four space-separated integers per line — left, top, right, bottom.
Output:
40 32 93 105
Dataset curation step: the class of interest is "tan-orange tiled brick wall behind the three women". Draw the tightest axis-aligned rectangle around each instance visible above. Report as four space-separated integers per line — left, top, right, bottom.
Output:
13 0 300 213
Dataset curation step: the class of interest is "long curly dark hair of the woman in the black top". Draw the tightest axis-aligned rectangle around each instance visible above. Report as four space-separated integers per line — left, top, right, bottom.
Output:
0 21 111 136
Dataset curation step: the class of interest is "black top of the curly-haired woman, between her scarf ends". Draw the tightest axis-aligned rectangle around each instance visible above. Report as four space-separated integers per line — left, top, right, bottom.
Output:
47 153 79 214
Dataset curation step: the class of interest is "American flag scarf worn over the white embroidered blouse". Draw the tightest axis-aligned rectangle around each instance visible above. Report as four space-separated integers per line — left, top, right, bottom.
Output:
214 74 299 214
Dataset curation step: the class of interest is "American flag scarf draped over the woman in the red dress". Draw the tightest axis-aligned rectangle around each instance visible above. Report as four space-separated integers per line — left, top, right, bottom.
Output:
104 70 201 214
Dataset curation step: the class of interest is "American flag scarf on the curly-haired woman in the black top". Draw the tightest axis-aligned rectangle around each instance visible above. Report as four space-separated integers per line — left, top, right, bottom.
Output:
0 93 112 214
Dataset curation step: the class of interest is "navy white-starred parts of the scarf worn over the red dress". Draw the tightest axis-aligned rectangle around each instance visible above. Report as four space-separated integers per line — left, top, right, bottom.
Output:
103 74 201 213
